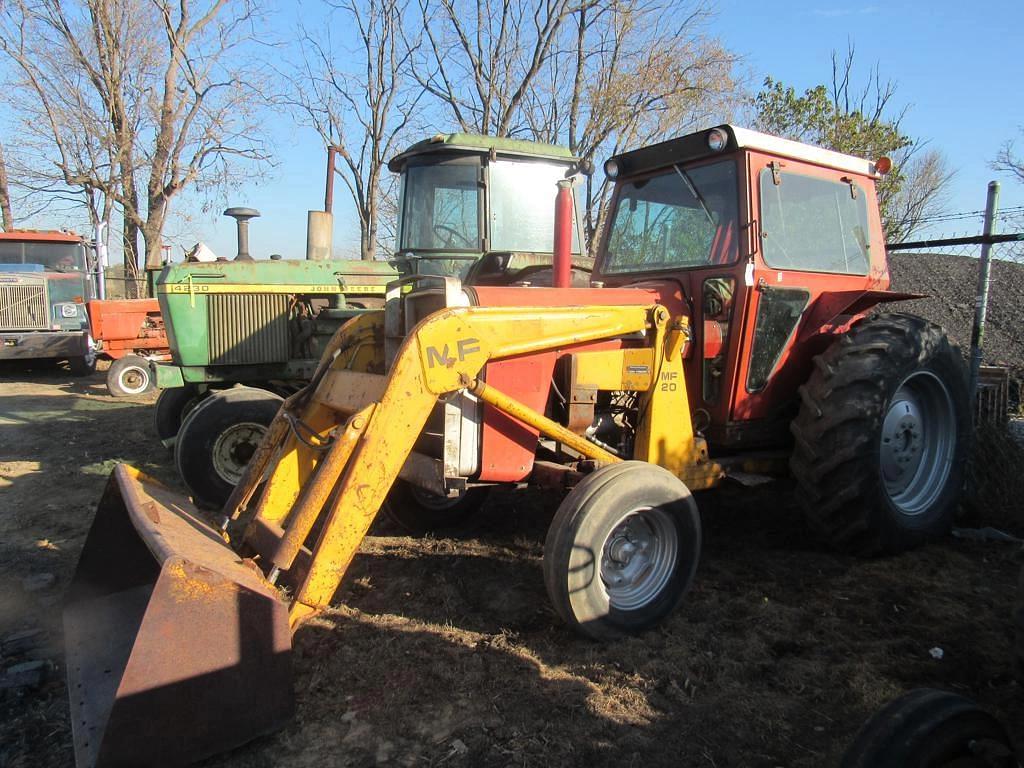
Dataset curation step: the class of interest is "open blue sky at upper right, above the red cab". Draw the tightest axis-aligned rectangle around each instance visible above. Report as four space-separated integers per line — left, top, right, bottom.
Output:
716 0 1024 234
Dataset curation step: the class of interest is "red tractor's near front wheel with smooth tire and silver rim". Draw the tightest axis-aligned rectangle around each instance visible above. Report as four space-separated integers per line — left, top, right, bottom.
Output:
544 461 700 640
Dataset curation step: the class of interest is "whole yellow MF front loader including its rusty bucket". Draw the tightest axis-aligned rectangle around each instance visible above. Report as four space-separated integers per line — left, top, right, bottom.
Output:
65 296 708 768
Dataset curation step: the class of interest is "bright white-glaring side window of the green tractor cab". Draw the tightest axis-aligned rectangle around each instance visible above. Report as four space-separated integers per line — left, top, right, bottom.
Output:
487 160 580 253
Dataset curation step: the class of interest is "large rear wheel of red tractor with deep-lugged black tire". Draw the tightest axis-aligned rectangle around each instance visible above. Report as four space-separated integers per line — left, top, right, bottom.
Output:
790 313 971 555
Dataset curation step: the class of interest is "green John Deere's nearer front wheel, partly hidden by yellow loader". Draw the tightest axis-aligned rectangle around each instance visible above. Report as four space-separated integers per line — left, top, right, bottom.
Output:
174 387 284 509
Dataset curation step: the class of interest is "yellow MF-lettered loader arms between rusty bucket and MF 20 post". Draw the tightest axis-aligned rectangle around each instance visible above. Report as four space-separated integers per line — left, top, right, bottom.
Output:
225 305 665 631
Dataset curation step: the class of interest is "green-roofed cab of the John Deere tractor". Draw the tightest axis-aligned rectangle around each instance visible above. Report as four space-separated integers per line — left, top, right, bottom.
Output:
388 133 592 286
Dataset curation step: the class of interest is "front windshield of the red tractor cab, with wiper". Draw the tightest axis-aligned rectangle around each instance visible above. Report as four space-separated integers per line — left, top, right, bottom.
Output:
601 160 739 273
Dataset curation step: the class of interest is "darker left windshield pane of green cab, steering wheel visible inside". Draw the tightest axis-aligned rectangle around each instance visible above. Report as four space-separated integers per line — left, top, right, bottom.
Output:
399 162 481 253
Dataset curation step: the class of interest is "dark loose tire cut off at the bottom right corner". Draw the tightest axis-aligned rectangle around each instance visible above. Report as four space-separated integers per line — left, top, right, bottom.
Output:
842 688 1018 768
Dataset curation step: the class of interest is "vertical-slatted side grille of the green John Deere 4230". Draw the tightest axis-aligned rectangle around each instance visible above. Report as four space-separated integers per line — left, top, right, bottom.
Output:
208 294 288 366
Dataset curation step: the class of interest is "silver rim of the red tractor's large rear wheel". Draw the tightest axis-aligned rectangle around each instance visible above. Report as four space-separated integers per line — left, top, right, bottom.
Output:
880 371 956 517
